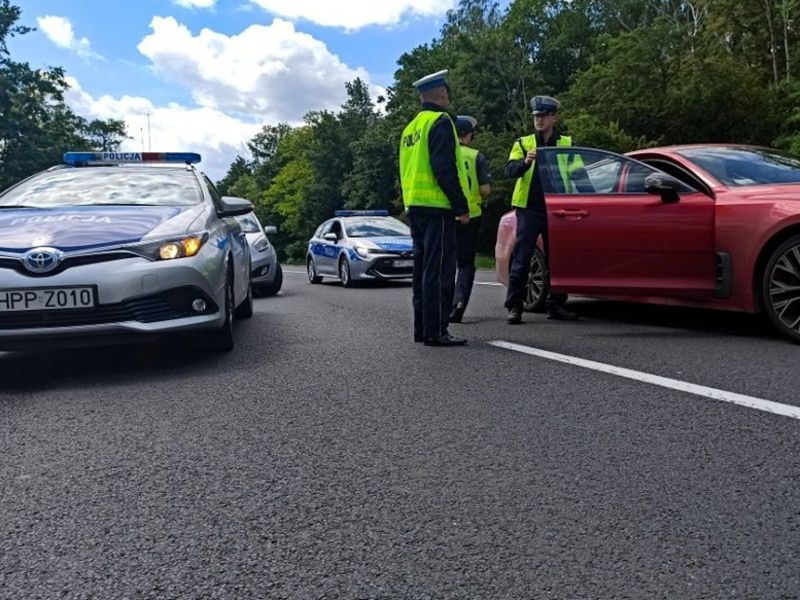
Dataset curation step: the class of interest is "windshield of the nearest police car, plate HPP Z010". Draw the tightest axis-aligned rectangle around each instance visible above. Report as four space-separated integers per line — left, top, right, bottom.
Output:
0 167 203 208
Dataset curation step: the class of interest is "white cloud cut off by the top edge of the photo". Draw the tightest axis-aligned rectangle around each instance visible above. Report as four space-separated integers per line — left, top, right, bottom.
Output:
250 0 456 29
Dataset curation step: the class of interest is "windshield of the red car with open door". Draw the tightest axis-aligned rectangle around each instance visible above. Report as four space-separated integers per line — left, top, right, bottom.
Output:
678 148 800 186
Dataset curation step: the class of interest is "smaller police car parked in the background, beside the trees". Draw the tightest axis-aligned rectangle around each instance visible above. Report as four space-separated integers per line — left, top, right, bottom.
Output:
306 210 414 287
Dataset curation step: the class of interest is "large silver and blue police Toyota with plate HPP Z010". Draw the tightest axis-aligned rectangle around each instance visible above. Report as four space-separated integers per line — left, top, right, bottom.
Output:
0 152 253 351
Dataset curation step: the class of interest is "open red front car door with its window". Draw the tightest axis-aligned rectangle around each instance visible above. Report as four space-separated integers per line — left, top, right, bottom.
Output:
537 147 716 298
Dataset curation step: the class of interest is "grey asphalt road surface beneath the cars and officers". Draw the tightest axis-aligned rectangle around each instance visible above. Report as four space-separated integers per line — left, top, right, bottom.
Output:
0 269 800 600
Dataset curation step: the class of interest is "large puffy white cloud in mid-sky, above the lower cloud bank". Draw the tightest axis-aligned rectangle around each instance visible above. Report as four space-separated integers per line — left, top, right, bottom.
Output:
138 17 383 123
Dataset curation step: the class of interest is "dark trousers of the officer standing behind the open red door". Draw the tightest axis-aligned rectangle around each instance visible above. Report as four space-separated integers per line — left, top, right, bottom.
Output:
506 204 567 310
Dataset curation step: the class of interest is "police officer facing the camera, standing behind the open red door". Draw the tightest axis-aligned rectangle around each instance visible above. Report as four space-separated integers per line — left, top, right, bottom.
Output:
505 96 578 325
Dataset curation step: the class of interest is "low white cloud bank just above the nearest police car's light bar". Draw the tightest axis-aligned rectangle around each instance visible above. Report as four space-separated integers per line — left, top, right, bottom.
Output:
65 77 262 180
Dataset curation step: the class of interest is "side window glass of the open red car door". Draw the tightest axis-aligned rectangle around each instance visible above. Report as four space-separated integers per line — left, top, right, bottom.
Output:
537 148 693 195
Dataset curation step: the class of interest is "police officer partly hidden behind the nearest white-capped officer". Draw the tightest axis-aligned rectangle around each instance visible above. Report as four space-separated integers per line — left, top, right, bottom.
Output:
450 115 492 323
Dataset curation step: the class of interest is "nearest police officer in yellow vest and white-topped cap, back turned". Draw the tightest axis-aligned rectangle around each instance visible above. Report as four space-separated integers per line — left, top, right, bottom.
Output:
400 70 469 346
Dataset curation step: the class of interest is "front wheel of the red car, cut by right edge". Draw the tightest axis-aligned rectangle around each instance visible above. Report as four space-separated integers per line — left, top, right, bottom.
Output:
761 235 800 343
